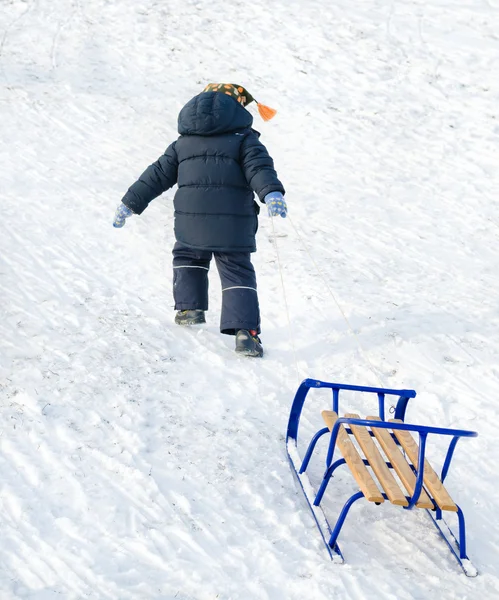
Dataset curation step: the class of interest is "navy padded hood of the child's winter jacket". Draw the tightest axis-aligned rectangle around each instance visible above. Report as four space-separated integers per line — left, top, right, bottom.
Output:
178 92 253 135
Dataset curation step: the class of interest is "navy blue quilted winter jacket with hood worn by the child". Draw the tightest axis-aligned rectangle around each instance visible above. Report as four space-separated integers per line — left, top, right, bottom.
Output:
122 92 284 252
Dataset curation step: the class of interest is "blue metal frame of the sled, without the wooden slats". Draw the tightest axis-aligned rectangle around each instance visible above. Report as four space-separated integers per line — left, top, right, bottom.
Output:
286 379 478 577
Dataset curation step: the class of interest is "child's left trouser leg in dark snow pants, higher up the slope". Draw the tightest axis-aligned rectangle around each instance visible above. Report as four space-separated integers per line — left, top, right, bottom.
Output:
173 242 212 310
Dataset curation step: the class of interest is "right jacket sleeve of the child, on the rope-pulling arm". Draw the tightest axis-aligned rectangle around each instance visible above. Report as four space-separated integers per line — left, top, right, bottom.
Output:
241 132 285 202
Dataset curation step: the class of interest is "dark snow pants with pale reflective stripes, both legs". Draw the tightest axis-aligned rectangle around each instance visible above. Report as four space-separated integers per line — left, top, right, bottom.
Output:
173 242 260 335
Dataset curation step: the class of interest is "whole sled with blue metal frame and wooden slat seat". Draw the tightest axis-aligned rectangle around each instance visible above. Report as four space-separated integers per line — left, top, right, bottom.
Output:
286 379 477 577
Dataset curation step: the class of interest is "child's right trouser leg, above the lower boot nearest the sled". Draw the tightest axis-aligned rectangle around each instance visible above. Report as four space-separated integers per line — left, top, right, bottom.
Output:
214 252 260 335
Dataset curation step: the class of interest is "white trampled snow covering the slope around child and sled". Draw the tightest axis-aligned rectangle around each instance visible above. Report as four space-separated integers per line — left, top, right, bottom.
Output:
0 0 499 600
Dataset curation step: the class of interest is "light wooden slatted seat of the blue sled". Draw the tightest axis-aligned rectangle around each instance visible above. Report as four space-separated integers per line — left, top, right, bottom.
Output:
322 410 458 512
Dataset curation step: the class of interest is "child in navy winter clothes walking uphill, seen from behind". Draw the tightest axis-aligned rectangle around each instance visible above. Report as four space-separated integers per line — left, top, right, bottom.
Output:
113 83 287 356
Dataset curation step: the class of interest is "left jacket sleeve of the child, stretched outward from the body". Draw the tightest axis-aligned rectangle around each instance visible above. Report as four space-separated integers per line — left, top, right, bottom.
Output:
122 142 178 215
